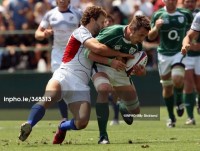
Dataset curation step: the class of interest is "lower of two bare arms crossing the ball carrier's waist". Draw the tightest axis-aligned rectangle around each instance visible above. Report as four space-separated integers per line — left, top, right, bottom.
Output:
84 49 126 71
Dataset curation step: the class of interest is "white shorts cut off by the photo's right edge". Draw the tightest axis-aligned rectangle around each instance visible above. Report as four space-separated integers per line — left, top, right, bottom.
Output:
183 56 200 75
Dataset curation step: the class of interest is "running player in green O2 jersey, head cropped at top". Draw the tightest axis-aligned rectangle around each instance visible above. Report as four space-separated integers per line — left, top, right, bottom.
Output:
148 0 193 127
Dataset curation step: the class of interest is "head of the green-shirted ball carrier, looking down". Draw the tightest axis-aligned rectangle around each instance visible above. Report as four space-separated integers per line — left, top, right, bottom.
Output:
127 15 151 44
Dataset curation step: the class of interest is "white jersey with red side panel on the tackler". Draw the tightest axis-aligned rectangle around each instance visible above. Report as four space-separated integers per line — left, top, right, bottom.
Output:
60 25 93 84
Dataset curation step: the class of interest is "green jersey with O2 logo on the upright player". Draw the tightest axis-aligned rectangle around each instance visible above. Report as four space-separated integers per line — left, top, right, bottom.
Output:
151 7 193 56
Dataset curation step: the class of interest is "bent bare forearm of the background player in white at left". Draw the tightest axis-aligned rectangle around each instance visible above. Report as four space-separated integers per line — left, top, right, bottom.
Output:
35 26 53 40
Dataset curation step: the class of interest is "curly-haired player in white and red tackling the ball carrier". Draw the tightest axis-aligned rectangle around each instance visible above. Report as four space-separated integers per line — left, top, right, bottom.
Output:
19 6 132 144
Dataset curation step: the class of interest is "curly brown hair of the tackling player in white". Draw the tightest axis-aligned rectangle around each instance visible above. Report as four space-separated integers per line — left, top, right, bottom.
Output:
81 6 107 26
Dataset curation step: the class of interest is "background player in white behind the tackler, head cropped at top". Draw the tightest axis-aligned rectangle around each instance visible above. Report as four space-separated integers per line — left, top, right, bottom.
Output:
35 0 82 122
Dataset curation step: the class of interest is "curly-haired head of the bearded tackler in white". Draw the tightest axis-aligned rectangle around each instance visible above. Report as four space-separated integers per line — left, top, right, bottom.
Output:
81 6 107 36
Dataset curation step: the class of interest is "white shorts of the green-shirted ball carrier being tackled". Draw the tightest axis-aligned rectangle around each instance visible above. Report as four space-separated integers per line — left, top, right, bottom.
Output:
93 64 131 86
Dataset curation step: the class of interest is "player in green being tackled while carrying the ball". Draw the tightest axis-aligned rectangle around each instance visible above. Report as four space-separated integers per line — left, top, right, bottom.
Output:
88 16 150 144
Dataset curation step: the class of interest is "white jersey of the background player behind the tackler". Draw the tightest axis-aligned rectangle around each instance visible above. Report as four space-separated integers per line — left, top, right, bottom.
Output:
40 6 82 48
